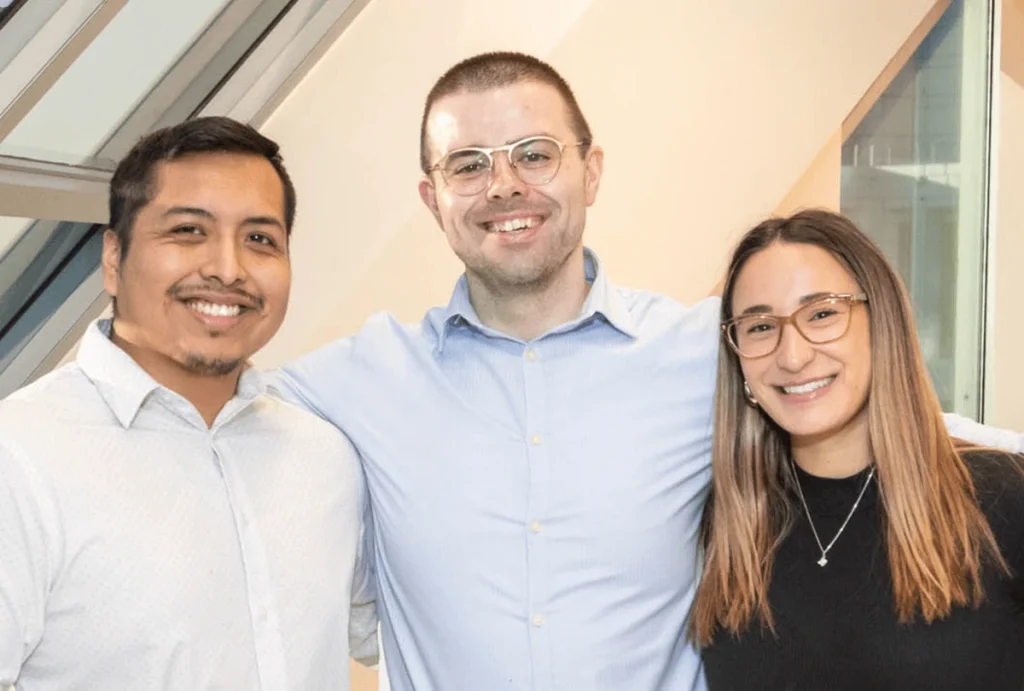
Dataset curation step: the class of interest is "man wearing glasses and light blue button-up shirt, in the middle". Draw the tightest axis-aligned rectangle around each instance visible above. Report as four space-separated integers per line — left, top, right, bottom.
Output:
279 53 719 691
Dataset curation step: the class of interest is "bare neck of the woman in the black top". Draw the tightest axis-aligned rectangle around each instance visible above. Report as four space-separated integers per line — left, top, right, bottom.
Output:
790 407 872 478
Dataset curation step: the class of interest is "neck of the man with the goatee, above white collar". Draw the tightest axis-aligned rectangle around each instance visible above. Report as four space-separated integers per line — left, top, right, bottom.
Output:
111 320 242 427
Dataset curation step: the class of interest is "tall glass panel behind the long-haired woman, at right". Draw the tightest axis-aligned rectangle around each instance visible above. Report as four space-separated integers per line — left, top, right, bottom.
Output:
841 0 990 417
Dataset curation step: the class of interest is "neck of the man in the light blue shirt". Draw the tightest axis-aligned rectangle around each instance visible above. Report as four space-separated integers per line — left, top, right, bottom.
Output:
466 250 590 341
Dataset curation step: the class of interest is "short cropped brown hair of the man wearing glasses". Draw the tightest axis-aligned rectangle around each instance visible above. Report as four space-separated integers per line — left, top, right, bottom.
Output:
420 52 593 173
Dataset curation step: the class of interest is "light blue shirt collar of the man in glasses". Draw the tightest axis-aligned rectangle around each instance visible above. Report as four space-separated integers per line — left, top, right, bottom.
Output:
437 248 636 353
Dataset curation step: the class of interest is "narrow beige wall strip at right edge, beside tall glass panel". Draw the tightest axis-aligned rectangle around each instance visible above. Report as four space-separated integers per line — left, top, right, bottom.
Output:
985 0 1024 430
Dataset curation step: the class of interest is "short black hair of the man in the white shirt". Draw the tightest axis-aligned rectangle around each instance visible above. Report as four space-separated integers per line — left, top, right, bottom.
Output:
110 117 296 258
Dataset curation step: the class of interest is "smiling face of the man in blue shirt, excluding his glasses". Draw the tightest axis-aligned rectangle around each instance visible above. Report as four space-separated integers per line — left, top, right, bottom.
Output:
420 81 603 292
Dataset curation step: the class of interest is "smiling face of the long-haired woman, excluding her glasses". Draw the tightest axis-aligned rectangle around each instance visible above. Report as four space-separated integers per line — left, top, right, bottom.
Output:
730 242 871 442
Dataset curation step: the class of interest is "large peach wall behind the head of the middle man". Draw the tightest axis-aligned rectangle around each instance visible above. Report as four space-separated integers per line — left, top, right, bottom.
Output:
253 0 935 365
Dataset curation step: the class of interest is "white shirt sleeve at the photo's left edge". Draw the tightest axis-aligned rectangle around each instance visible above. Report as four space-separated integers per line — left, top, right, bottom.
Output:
0 440 54 682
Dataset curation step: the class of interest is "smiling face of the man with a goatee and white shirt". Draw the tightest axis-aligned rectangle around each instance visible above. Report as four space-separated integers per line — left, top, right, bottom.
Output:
103 154 291 383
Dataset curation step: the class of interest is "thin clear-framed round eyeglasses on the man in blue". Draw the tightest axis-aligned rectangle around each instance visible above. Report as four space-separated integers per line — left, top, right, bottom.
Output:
427 136 590 197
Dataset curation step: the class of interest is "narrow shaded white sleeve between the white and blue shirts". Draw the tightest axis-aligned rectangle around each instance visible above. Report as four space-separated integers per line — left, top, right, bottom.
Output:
348 464 380 666
